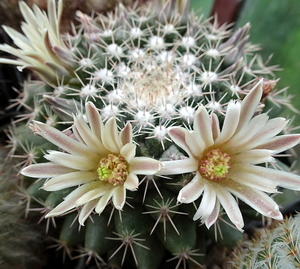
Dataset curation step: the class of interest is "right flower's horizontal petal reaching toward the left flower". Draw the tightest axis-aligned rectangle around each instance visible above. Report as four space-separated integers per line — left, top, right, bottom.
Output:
156 158 199 176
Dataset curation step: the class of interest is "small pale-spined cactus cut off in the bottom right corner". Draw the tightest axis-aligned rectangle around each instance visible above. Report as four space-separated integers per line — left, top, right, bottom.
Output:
228 214 300 269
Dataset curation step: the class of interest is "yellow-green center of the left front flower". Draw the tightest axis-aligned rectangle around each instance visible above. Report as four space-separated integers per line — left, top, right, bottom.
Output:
97 153 128 186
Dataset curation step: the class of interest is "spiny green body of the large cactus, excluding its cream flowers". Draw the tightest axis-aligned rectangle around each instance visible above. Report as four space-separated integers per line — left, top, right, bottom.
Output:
0 0 298 269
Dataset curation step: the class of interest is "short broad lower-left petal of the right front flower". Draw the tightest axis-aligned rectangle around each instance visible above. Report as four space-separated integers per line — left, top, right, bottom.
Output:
177 172 204 204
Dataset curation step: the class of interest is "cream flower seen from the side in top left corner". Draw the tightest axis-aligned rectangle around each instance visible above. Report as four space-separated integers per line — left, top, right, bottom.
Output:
0 0 73 83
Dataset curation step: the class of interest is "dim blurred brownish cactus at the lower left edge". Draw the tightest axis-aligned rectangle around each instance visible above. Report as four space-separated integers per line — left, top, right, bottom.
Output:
0 148 44 269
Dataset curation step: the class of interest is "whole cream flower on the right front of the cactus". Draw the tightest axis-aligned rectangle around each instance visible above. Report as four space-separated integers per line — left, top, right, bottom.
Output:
159 82 300 230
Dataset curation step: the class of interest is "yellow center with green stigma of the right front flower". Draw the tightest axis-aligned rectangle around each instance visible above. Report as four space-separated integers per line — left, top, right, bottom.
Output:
198 148 231 181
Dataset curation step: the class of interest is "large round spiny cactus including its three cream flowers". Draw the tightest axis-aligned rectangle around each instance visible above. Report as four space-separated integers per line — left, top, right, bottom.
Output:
0 0 300 269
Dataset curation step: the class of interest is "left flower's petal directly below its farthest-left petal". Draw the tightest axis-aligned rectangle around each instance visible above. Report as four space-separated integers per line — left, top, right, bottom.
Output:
43 171 97 191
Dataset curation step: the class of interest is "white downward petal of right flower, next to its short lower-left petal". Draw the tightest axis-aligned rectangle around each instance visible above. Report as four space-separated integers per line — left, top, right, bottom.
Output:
193 184 216 223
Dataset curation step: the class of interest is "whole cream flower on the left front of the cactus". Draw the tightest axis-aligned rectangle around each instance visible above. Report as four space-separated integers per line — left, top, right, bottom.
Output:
21 102 161 225
